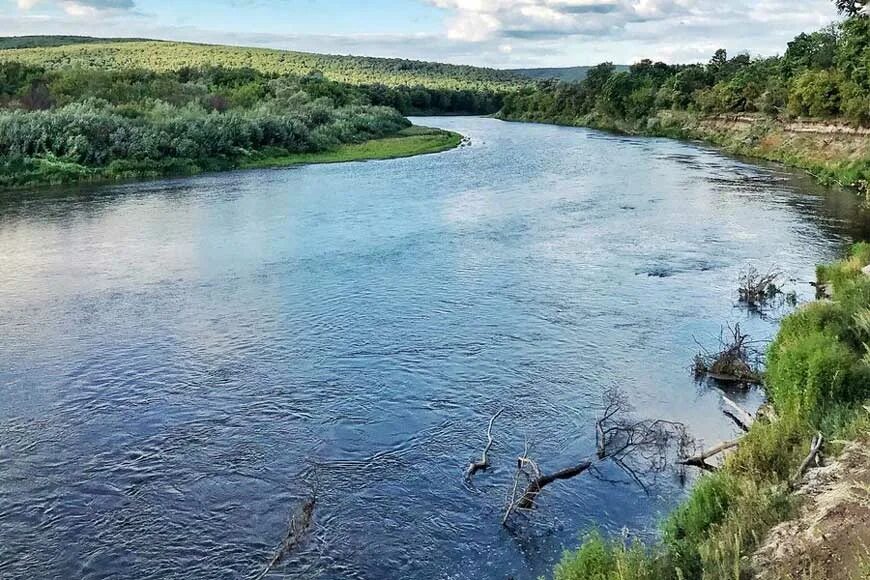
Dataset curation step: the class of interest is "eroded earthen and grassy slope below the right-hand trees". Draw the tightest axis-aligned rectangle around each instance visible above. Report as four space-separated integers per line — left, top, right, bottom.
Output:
498 111 870 192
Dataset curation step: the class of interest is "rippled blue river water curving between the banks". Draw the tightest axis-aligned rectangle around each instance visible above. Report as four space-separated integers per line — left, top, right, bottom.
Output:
0 118 867 579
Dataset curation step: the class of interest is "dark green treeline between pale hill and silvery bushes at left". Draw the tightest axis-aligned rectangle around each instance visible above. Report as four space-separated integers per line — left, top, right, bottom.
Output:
0 61 502 115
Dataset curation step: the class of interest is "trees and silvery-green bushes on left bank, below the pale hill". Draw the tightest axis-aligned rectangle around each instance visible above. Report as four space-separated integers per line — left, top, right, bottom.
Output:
0 43 500 187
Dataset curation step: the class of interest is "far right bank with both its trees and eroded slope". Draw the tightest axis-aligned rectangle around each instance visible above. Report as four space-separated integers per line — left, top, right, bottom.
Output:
499 14 870 191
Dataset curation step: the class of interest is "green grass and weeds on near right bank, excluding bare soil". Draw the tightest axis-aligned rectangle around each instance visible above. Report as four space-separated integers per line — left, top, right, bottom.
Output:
554 244 870 580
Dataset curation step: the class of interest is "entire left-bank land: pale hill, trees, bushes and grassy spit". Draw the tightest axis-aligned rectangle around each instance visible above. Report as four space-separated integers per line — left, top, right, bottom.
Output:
0 37 523 188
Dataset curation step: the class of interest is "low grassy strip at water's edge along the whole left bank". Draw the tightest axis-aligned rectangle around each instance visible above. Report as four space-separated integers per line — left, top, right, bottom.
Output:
0 126 462 189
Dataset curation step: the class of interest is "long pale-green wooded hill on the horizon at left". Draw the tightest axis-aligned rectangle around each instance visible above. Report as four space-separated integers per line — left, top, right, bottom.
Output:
0 36 529 91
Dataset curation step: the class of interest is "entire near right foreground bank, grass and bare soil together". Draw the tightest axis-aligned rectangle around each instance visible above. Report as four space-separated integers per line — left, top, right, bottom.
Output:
555 243 870 580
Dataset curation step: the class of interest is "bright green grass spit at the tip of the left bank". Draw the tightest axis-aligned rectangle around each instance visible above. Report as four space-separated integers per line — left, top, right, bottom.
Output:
239 126 462 169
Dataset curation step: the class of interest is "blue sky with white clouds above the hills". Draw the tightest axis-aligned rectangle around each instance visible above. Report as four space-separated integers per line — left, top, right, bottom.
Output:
0 0 837 68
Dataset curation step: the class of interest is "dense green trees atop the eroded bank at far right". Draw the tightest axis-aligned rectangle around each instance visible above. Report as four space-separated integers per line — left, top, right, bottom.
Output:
501 16 870 125
